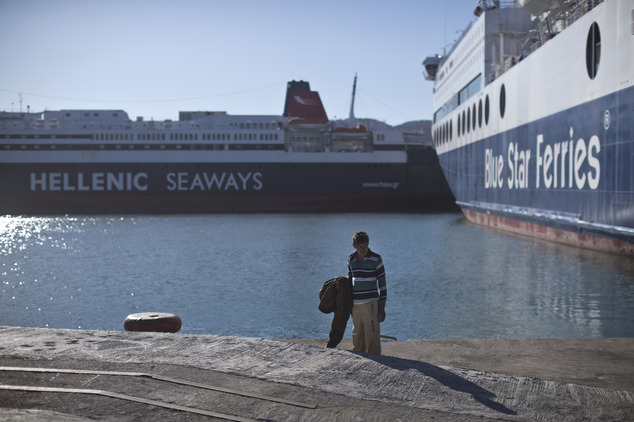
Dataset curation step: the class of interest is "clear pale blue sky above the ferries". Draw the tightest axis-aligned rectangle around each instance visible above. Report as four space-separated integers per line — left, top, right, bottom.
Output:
0 0 477 125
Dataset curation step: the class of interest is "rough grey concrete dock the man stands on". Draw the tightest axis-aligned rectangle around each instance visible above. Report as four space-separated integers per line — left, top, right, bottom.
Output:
0 326 634 422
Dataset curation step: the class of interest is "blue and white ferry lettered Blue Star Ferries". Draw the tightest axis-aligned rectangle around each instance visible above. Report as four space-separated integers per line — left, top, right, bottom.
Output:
423 0 634 254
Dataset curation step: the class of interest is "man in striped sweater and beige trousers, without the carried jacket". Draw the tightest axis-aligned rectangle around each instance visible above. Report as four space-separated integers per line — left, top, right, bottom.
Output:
348 232 387 355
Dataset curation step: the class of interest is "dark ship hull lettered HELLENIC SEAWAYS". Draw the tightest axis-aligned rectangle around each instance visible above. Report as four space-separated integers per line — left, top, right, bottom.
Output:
0 156 453 214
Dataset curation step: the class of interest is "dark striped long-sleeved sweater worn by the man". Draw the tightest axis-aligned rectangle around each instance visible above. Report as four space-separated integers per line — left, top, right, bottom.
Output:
348 250 387 306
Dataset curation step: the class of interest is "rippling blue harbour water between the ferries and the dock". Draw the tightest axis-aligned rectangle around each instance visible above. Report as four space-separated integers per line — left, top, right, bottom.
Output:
0 213 634 340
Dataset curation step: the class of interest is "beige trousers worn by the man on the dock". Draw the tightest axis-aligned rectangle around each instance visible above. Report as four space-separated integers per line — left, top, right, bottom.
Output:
352 300 381 355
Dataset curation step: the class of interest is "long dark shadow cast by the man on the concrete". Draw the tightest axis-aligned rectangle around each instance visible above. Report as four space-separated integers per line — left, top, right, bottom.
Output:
352 352 517 415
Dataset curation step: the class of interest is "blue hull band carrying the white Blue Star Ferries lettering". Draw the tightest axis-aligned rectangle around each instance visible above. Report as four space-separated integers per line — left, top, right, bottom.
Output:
439 88 634 247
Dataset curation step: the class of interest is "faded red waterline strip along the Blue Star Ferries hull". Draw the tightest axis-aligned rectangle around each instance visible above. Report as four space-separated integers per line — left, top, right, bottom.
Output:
462 209 634 255
